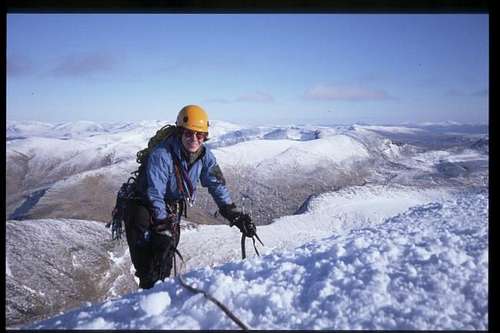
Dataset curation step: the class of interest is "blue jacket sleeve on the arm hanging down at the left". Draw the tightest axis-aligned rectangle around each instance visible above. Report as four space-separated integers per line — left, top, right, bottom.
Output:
146 147 172 219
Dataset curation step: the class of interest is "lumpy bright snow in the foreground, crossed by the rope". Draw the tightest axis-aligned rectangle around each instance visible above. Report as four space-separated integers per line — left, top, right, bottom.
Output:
27 190 488 330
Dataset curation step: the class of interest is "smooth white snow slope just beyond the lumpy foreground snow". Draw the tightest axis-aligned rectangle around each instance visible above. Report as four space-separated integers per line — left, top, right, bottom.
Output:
179 185 451 270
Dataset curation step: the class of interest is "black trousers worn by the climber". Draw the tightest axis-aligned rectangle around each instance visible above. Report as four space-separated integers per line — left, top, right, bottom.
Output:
125 200 180 289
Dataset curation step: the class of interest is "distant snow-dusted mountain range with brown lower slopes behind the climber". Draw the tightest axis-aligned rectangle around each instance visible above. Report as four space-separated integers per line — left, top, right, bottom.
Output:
6 121 488 224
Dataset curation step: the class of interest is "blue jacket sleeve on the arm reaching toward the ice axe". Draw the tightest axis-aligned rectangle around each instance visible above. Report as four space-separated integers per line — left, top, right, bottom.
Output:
200 149 233 208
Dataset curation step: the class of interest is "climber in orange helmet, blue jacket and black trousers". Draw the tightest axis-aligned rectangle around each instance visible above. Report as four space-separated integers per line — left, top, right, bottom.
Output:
124 105 256 289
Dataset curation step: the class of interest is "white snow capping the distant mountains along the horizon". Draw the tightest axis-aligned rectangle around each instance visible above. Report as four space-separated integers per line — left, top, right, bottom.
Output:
6 121 487 210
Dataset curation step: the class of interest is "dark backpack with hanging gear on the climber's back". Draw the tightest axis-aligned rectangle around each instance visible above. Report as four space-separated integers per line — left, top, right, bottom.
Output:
106 124 177 240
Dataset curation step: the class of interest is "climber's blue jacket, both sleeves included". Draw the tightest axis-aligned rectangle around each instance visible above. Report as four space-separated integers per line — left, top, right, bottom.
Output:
137 135 232 219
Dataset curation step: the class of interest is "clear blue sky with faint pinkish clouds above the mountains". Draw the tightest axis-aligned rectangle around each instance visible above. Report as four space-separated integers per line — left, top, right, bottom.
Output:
7 14 489 125
